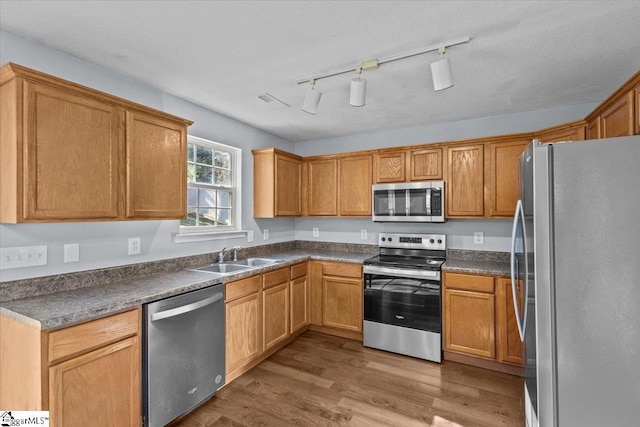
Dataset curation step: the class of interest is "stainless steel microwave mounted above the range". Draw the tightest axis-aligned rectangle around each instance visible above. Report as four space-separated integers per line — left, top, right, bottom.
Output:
371 181 444 222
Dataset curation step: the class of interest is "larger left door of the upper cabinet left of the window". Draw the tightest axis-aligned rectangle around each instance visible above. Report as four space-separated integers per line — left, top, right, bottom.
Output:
22 82 124 221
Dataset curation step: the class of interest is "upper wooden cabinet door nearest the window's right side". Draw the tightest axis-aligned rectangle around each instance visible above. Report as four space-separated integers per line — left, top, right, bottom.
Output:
275 153 302 216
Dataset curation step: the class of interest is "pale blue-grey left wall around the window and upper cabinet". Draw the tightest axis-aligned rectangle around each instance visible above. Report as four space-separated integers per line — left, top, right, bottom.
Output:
0 30 295 282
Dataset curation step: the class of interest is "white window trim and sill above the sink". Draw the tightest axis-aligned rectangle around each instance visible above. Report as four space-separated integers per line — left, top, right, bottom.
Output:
174 135 247 243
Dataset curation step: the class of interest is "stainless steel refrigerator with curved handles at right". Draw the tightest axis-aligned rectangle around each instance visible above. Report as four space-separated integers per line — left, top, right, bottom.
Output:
511 136 640 427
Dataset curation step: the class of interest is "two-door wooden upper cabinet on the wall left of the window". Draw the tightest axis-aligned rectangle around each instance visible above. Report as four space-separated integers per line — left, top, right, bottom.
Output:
0 64 192 223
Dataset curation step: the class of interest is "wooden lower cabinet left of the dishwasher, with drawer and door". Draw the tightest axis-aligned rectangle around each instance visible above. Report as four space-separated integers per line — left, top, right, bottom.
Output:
0 309 142 427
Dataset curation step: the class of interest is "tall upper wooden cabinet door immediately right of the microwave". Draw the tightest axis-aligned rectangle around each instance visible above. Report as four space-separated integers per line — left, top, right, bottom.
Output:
446 144 484 216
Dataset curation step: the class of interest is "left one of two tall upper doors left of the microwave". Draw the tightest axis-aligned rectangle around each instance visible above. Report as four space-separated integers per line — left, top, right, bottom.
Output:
308 159 338 216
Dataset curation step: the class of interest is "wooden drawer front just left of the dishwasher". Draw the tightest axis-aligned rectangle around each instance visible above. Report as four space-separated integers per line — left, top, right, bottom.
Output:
48 309 139 363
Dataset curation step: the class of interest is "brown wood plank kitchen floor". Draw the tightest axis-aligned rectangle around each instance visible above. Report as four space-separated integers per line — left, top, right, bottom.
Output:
174 332 524 427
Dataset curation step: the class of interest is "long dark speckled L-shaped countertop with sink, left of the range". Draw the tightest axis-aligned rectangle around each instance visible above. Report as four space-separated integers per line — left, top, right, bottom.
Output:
0 248 372 330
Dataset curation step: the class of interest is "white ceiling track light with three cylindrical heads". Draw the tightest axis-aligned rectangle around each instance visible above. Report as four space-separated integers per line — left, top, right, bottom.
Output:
296 37 471 114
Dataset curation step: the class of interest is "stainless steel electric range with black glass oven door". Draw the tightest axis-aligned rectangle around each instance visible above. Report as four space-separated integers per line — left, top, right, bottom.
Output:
364 233 446 363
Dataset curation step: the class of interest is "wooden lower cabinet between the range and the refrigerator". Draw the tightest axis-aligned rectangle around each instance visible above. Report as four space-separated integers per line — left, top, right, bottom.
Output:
443 272 524 374
